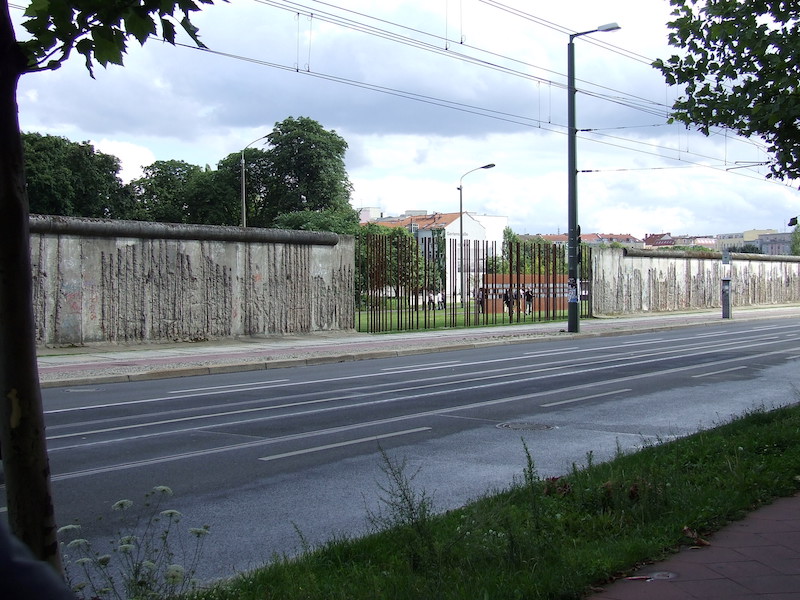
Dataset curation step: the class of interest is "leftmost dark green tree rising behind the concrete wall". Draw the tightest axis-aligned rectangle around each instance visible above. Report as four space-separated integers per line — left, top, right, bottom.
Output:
22 133 124 218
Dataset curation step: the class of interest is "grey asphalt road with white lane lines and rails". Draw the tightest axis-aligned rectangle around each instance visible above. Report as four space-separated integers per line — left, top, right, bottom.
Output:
20 319 800 578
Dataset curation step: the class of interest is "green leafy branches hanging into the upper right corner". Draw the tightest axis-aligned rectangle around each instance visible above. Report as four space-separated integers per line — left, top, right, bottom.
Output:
653 0 800 179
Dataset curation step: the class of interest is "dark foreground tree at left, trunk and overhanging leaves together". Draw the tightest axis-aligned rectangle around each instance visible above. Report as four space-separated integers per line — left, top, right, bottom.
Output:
0 0 219 568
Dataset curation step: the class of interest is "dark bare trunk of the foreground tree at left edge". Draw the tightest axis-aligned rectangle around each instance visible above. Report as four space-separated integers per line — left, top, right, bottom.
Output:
0 1 61 570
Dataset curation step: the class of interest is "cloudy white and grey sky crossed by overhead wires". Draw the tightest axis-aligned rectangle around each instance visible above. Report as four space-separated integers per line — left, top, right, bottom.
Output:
11 0 800 237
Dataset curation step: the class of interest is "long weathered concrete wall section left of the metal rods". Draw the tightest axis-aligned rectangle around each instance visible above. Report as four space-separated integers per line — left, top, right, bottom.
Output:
31 216 354 345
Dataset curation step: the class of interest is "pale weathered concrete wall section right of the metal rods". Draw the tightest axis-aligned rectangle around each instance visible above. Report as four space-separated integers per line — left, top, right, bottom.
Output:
592 248 800 315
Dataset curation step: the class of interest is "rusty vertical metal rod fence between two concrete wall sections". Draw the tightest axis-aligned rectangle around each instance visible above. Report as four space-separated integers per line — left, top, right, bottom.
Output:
355 232 592 333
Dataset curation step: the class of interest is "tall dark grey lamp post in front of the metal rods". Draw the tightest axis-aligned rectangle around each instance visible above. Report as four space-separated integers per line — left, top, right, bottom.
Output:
567 23 620 333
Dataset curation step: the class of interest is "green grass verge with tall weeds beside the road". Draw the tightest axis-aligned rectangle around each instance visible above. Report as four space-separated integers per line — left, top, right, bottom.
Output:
184 406 800 600
